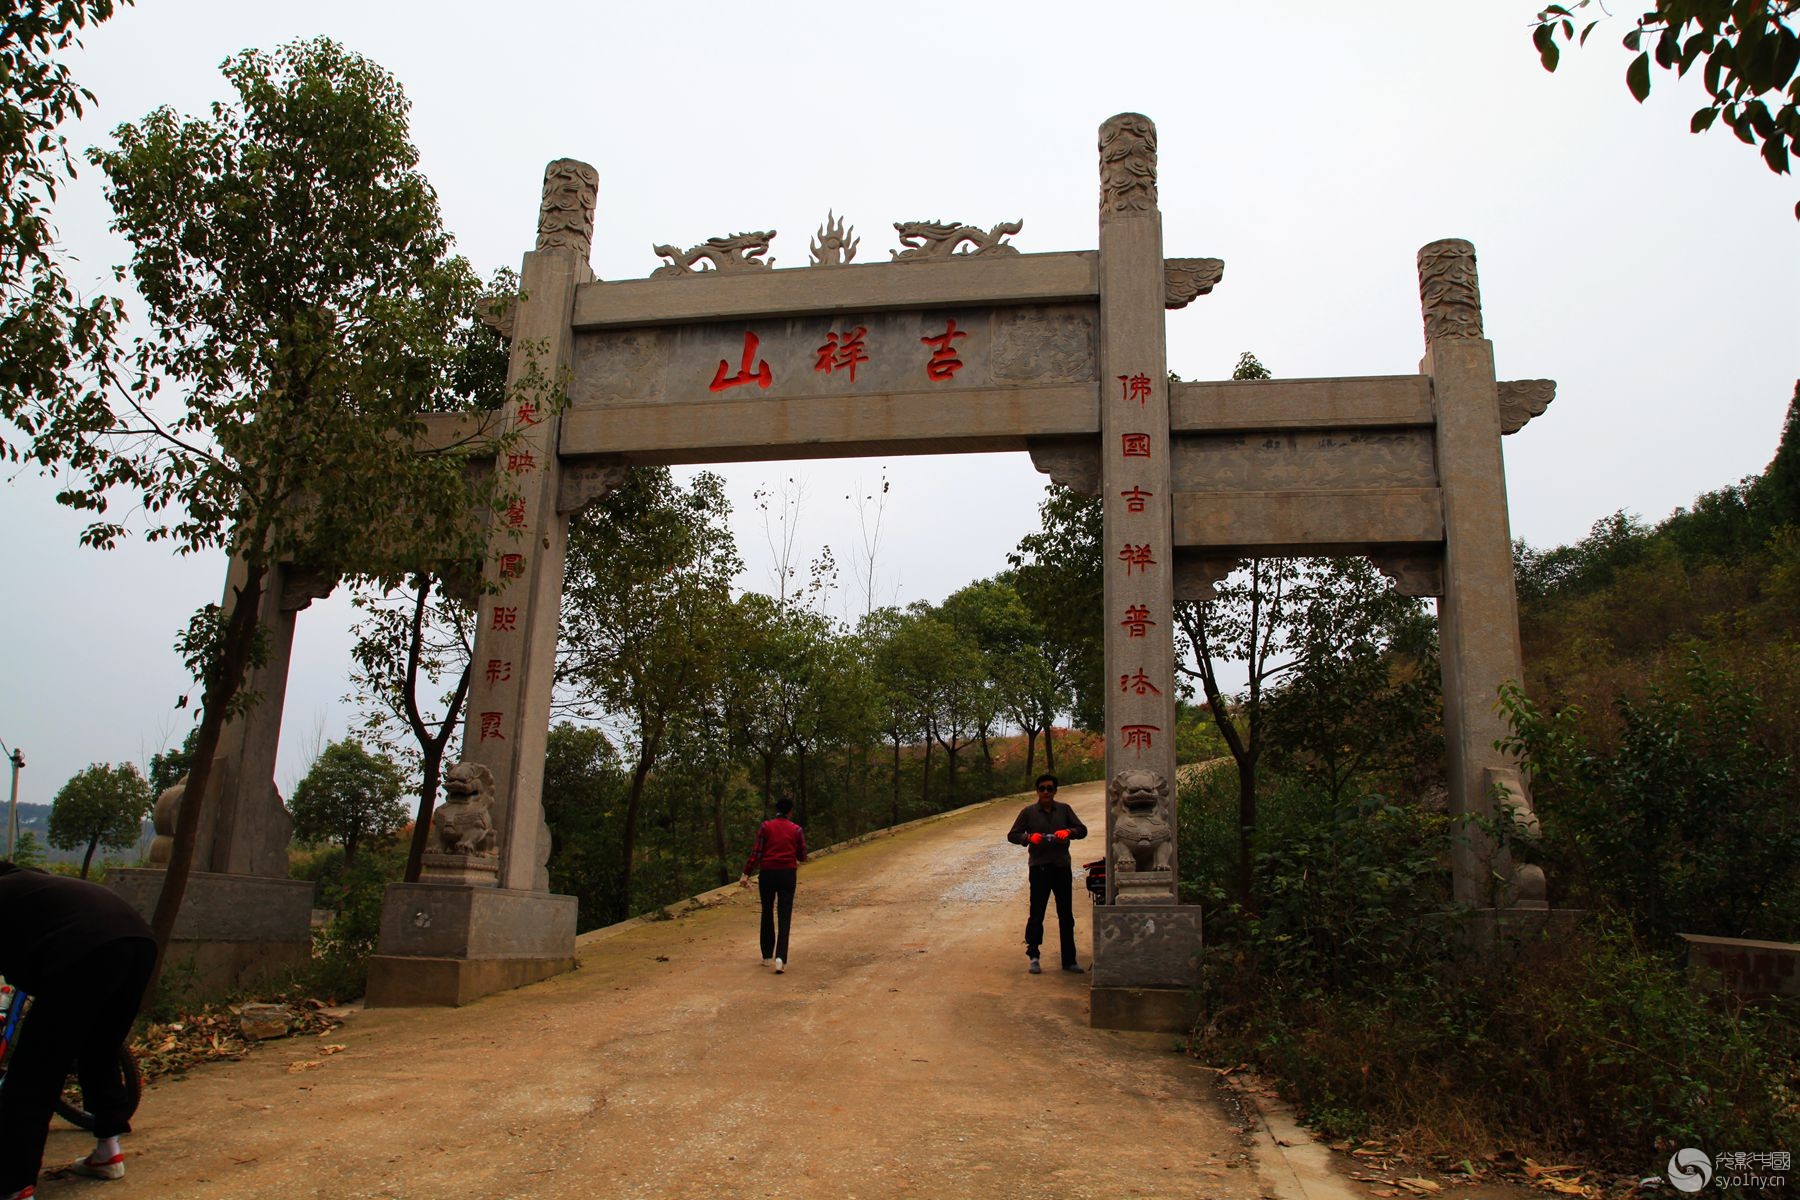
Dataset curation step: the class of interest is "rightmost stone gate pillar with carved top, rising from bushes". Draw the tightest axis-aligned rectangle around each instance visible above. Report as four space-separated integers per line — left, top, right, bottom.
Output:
1418 237 1543 909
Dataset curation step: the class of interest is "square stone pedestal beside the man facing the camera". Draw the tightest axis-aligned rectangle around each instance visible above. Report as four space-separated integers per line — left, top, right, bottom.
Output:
1087 903 1201 1033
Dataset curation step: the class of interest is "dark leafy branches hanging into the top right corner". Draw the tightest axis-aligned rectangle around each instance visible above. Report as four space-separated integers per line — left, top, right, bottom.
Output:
1532 0 1800 219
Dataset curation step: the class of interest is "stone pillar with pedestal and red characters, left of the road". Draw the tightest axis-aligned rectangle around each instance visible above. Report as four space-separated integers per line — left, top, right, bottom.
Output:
367 158 599 1006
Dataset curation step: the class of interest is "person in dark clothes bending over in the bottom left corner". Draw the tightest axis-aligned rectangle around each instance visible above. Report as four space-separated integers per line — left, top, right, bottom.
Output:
0 860 157 1200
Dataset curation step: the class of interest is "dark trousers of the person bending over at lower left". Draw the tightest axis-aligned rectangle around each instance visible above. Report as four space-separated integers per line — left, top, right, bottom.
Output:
0 937 157 1195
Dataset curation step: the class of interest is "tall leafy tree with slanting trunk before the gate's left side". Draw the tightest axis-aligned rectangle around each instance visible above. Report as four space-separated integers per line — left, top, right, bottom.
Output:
52 40 518 978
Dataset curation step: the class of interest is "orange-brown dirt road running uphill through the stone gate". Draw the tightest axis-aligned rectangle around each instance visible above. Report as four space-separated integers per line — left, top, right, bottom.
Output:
38 784 1264 1200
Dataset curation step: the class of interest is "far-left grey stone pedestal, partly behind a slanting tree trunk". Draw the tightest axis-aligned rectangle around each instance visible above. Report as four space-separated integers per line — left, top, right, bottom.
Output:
106 867 313 993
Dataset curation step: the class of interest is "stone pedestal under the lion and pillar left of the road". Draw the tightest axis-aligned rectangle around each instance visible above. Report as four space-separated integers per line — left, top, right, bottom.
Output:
365 882 576 1007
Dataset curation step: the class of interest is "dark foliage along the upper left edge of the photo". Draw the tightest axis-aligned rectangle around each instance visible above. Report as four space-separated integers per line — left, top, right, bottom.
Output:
0 0 131 464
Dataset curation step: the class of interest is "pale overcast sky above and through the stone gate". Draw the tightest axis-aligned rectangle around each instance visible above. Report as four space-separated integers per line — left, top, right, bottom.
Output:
0 0 1800 802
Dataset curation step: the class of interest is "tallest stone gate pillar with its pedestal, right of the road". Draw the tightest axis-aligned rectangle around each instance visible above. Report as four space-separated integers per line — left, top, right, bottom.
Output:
1089 113 1201 1029
